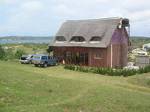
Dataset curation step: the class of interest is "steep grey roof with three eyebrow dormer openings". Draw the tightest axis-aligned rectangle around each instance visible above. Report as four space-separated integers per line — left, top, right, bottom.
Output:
50 18 122 48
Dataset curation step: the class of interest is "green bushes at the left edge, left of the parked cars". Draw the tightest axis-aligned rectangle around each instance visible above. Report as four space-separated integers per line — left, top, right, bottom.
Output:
0 45 26 61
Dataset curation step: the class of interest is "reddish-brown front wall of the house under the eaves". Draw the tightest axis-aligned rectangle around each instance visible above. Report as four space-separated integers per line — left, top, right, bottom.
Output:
54 47 107 67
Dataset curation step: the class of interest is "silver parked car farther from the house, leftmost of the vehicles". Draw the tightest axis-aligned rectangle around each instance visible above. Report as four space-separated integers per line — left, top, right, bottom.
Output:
19 55 33 64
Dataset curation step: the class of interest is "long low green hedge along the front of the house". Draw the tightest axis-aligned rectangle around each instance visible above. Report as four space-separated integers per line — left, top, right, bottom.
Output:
64 65 150 77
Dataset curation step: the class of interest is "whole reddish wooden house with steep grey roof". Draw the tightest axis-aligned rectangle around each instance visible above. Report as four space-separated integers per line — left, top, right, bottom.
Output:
50 18 129 68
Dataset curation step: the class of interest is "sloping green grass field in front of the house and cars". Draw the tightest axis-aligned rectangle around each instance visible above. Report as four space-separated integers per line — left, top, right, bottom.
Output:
0 61 150 112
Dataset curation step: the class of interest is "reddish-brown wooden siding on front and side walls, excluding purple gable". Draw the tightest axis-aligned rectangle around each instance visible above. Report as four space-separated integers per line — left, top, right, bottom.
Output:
54 44 127 68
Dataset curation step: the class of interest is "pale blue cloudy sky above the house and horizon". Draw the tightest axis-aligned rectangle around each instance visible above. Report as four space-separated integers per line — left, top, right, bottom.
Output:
0 0 150 37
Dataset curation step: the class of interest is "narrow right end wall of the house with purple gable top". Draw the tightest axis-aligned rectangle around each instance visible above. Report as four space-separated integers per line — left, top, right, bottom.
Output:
109 29 128 68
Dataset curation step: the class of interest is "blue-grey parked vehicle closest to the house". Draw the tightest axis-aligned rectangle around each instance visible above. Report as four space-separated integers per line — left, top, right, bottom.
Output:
32 54 57 67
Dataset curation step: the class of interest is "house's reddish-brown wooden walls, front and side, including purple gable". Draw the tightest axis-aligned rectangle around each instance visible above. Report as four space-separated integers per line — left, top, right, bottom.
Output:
54 29 128 68
